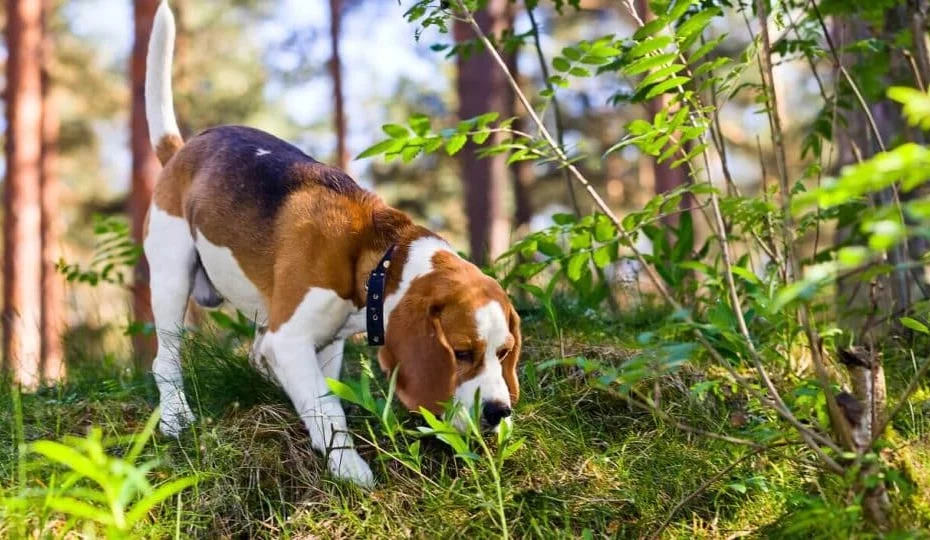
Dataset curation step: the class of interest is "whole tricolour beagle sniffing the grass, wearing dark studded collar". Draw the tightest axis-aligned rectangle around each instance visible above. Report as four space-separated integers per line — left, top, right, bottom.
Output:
143 2 520 486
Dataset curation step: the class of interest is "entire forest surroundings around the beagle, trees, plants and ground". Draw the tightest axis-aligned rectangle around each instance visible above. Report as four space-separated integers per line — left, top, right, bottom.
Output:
0 0 930 538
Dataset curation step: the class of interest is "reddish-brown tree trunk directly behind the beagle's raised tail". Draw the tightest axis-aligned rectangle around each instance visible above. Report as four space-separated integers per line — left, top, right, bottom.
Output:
129 0 159 368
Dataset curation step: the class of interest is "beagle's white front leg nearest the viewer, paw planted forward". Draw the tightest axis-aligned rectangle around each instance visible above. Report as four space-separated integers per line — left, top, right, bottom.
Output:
262 325 374 487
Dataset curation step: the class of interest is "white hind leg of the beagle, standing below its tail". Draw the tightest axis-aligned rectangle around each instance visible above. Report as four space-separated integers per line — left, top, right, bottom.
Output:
143 204 197 437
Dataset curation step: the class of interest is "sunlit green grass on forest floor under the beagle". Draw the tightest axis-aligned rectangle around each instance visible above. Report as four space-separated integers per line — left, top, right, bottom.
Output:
0 309 930 538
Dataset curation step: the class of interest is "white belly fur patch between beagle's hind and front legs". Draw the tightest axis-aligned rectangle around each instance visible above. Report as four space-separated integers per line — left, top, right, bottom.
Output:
195 231 268 324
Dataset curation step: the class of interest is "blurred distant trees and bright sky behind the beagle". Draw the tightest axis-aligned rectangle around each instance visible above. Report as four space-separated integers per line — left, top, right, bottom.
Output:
3 0 830 384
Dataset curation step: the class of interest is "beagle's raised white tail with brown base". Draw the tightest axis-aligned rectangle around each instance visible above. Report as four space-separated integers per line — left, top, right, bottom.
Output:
145 0 184 165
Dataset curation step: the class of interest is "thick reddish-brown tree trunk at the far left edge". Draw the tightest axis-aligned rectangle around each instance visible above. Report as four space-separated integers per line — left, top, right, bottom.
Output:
3 0 42 388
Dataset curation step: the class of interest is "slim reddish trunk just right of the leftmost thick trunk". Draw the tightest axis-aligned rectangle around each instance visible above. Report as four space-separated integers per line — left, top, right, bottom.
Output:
40 0 65 381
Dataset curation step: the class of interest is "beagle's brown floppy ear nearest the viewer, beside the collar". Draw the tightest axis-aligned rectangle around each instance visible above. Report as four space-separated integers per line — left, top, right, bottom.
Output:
378 294 456 413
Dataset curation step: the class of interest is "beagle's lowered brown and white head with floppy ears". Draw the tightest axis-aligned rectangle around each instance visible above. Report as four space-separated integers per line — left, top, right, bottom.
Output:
378 251 521 430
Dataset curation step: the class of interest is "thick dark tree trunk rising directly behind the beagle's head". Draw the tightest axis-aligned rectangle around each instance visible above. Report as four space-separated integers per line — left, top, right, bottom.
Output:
455 0 514 265
